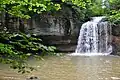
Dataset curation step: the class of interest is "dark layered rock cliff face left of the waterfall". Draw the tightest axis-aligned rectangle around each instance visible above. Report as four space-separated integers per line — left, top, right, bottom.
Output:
0 7 82 52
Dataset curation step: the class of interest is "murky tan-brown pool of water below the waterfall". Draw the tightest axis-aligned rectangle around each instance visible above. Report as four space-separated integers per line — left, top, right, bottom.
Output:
0 56 120 80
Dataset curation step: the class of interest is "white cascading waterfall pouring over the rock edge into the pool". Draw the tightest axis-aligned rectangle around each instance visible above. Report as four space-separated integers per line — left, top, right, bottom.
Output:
73 17 112 55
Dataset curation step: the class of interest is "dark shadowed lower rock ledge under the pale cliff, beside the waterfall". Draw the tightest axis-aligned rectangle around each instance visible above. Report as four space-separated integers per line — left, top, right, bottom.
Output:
39 35 77 52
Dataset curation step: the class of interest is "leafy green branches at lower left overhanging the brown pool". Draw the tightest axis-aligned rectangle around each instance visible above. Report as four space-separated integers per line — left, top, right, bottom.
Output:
0 32 56 73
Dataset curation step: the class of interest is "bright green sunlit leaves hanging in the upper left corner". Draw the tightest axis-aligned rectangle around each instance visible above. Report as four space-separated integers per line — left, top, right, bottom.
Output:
0 0 60 19
